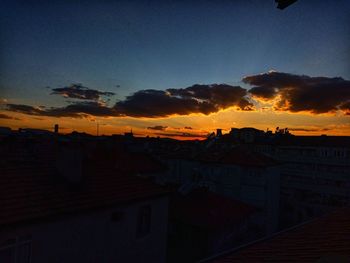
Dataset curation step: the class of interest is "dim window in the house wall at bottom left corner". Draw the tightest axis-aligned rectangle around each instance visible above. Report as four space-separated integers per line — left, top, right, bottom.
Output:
0 235 32 263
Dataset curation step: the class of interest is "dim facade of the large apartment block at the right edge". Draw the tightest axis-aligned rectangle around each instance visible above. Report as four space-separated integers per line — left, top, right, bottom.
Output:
257 145 350 228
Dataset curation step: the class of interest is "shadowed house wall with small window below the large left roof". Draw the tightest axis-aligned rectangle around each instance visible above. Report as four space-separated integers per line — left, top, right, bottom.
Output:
0 197 168 263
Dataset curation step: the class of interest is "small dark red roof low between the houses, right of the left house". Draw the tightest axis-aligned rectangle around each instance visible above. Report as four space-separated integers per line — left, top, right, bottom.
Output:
170 189 257 228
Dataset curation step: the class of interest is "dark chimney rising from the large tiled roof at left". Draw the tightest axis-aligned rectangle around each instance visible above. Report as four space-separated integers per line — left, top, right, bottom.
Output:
56 144 83 184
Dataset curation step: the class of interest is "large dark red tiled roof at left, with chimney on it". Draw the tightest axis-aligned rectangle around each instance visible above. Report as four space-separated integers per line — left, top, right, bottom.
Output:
0 162 166 226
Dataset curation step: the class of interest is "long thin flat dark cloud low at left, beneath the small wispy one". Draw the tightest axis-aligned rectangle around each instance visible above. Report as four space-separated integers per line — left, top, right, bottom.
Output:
6 101 116 118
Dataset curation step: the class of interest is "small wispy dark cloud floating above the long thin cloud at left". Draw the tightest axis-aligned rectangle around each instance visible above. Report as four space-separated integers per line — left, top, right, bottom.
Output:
51 84 115 101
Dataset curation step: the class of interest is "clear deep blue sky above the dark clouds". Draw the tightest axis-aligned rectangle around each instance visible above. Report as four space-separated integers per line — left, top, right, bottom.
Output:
0 0 350 103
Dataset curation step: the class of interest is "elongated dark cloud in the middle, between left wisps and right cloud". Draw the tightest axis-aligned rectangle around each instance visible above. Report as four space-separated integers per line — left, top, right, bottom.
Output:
114 84 253 118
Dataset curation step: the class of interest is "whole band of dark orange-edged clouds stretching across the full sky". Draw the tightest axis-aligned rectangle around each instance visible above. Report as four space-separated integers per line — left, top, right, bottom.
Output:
3 71 350 119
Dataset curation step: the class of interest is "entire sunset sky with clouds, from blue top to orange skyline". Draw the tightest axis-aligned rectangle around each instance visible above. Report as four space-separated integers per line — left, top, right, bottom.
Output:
0 0 350 139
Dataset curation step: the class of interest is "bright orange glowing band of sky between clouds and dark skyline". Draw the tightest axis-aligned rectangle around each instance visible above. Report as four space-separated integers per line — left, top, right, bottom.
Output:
0 108 350 140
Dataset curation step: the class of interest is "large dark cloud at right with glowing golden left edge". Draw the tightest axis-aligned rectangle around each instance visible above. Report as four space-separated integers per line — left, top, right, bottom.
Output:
243 71 350 115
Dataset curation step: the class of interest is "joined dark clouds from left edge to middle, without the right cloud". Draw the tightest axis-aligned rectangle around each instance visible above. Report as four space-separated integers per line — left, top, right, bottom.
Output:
6 84 253 118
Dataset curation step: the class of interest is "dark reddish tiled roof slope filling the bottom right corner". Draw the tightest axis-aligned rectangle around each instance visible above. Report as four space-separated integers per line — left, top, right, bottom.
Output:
206 207 350 263
